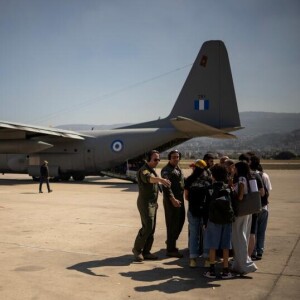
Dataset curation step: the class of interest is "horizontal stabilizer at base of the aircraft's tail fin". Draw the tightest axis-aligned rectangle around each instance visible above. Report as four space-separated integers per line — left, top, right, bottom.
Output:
170 116 241 139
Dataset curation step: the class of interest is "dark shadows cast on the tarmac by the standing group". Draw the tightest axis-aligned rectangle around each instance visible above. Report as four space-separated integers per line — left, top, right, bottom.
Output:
67 249 252 294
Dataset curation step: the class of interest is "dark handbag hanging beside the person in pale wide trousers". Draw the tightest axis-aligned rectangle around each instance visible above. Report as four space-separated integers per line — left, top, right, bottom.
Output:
234 180 261 217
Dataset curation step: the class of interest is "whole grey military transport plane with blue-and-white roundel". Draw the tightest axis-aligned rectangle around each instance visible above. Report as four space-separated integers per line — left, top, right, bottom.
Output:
0 41 242 181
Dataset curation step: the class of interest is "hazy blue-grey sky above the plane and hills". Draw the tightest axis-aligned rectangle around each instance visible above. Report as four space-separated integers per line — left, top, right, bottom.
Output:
0 0 300 126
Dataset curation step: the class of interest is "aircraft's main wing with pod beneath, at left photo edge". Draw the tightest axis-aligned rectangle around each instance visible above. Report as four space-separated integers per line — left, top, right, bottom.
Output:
0 121 94 153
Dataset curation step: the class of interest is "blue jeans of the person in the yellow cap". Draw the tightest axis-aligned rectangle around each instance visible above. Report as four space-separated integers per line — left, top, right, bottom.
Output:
187 211 203 258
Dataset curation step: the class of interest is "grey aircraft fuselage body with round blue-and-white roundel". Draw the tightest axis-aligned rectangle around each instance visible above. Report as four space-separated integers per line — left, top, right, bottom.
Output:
0 128 183 177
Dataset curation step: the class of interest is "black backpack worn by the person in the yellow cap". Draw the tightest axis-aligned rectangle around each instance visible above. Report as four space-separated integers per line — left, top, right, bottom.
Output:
189 178 210 217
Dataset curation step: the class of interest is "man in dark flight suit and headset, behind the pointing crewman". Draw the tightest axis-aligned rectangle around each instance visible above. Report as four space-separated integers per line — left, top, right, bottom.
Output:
161 150 185 258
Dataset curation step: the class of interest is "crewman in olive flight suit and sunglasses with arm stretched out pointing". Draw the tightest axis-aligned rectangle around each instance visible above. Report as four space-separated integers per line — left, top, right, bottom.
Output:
132 150 171 262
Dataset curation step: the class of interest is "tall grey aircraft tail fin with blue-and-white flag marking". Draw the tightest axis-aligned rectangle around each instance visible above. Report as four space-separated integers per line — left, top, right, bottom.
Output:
168 41 240 129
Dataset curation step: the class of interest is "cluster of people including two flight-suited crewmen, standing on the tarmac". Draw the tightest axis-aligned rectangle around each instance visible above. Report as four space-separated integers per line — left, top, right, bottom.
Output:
132 150 272 279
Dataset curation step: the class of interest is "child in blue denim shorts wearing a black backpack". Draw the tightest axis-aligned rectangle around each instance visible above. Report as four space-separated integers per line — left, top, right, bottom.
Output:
203 164 234 279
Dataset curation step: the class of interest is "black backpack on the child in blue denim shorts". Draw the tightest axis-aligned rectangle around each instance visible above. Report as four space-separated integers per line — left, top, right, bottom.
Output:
208 184 235 224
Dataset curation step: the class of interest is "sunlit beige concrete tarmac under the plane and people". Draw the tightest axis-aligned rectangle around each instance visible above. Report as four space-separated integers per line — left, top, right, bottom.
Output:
0 170 300 300
